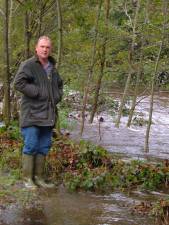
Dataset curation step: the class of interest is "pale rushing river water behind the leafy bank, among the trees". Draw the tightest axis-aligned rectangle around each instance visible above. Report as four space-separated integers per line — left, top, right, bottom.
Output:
71 94 169 159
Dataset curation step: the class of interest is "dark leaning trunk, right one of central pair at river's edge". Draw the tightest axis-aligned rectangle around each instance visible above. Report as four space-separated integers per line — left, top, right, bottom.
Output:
89 0 110 123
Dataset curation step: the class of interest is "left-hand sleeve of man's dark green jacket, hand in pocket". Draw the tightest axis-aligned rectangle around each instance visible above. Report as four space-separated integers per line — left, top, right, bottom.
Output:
14 63 39 98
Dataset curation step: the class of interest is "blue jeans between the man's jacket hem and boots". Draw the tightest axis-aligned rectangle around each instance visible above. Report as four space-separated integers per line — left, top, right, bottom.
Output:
21 126 52 155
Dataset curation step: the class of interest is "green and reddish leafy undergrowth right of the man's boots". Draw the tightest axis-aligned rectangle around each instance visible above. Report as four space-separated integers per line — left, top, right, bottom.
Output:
45 140 169 192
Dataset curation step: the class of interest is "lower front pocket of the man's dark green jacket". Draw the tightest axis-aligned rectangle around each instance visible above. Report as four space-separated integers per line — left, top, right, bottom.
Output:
30 101 49 119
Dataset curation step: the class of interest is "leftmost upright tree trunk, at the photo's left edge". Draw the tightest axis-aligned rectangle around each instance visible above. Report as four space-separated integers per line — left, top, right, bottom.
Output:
3 0 11 126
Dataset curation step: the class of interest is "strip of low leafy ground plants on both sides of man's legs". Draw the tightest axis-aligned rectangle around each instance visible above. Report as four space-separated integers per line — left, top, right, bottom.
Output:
0 121 169 192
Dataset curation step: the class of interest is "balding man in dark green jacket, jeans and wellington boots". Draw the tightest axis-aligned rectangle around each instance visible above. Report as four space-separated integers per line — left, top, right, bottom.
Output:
14 36 63 189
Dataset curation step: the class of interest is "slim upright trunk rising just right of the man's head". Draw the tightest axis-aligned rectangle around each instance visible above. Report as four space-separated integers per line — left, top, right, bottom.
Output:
56 0 63 69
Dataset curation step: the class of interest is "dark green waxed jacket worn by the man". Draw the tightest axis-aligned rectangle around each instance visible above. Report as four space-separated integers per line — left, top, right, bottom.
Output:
14 56 63 127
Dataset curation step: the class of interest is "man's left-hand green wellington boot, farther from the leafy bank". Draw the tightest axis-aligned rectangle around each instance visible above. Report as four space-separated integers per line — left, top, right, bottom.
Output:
22 154 37 190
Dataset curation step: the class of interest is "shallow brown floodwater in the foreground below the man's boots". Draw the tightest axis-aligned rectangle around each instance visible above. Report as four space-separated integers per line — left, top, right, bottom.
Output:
0 187 164 225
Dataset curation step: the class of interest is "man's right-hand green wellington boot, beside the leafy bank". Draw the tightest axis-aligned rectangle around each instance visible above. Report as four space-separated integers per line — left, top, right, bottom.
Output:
35 154 55 188
